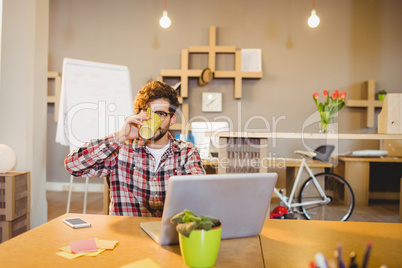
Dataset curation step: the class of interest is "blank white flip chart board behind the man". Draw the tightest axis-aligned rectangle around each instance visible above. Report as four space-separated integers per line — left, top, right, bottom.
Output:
56 59 133 149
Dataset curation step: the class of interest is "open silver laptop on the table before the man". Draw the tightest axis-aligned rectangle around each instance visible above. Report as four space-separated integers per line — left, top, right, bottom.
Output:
140 173 278 246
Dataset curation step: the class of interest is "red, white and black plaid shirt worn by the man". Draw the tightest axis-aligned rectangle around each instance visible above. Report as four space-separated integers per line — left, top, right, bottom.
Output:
64 133 205 217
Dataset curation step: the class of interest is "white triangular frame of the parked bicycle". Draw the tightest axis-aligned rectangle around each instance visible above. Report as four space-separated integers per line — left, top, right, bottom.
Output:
274 157 330 211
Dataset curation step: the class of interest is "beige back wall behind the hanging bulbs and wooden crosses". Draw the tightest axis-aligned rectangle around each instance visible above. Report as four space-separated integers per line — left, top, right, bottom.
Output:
48 0 402 186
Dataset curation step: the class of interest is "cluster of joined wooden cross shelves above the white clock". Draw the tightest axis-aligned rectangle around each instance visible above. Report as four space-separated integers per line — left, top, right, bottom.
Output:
161 26 262 99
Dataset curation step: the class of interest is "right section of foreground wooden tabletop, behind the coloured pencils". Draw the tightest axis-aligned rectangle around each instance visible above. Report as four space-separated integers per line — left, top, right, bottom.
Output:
260 220 402 268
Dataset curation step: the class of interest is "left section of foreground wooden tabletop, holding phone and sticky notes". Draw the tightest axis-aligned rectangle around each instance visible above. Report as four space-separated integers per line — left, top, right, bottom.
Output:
0 214 263 268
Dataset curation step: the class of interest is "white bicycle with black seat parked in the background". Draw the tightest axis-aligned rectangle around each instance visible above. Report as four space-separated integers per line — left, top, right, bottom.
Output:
274 145 355 221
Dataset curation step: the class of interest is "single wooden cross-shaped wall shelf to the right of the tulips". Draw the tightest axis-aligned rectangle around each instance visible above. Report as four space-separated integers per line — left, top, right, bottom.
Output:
346 80 383 127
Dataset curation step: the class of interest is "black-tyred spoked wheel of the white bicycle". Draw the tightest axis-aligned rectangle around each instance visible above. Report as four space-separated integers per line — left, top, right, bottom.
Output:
299 172 355 221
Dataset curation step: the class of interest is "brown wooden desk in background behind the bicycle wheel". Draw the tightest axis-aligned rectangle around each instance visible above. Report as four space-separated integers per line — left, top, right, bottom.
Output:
335 157 402 206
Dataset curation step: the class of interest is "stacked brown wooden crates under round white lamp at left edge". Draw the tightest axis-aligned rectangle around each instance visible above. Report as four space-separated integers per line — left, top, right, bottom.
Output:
0 171 30 242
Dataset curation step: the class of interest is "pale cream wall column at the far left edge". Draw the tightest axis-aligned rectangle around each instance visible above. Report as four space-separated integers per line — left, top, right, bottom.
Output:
0 0 49 228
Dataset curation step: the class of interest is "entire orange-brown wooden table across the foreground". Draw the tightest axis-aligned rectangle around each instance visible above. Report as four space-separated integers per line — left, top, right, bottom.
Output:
0 214 402 268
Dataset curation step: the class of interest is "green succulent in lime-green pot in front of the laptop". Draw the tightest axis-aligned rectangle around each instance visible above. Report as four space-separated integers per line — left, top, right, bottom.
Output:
170 210 222 267
